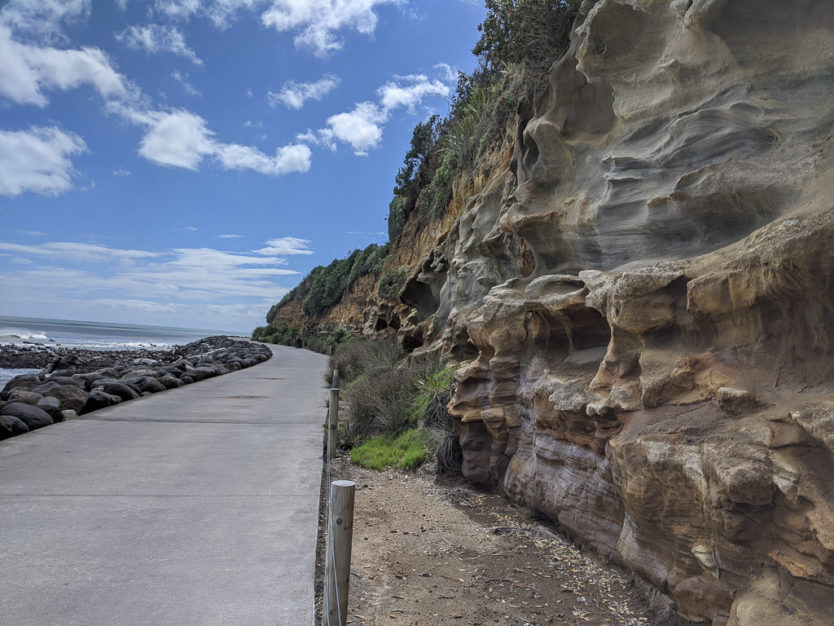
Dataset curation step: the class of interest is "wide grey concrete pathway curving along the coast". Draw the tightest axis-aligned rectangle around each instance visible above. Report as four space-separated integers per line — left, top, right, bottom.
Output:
0 346 327 626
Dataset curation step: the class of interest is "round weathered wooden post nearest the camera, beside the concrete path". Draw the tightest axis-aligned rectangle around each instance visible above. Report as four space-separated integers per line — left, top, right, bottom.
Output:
324 480 356 626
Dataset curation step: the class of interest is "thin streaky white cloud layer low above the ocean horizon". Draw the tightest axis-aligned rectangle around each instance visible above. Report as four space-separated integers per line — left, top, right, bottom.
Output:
0 242 296 331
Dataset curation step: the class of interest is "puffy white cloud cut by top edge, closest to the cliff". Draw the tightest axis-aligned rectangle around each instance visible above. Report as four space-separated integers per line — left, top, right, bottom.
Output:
261 0 404 57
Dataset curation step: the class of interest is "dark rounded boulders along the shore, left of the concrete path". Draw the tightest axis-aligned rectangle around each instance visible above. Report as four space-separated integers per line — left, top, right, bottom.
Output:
0 336 272 440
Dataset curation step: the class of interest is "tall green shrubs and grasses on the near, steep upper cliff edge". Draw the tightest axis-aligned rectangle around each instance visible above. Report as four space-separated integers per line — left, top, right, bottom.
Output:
388 0 579 242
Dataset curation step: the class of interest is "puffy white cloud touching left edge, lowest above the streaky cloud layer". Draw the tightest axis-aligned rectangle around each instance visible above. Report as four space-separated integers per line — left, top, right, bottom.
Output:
0 126 87 196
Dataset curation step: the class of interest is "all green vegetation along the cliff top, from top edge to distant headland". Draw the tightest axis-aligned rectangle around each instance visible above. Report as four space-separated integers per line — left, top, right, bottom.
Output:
253 0 579 343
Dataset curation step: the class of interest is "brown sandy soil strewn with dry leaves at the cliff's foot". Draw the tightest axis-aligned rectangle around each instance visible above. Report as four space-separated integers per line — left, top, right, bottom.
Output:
317 457 676 626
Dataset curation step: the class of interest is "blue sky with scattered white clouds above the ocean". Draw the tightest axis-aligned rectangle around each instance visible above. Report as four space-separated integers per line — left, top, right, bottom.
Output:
0 0 485 332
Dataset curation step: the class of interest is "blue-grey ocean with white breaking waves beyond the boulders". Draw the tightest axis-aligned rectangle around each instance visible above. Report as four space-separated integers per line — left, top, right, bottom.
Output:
0 315 241 389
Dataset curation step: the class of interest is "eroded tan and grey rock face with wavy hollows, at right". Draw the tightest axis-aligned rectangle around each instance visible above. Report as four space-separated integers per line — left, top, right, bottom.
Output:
390 0 834 624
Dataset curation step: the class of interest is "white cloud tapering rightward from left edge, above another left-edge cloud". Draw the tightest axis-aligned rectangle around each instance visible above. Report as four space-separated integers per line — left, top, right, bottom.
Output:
0 23 135 107
